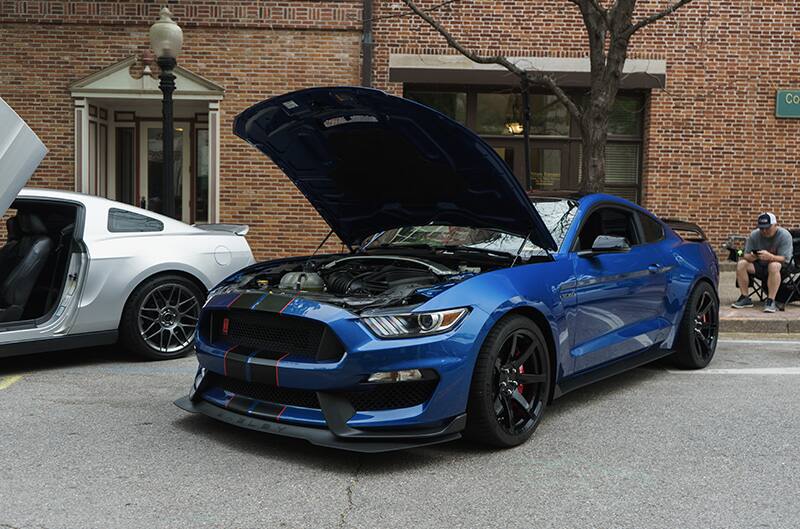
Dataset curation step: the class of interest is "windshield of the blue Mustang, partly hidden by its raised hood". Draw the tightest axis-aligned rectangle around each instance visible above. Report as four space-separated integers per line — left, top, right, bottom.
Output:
363 198 578 260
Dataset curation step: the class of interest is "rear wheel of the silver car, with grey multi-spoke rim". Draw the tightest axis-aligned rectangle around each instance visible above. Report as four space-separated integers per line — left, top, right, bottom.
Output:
120 274 204 360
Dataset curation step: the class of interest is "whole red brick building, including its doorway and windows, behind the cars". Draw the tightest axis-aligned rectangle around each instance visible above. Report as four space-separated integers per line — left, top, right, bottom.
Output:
0 0 800 258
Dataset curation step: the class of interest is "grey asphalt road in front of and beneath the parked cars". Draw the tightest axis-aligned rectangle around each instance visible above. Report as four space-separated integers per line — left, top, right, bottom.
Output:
0 338 800 529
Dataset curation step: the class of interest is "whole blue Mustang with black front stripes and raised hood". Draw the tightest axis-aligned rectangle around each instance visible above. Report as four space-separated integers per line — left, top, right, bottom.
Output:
176 87 719 452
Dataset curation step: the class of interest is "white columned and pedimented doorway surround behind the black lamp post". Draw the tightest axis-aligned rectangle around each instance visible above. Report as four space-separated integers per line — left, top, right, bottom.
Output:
69 57 225 222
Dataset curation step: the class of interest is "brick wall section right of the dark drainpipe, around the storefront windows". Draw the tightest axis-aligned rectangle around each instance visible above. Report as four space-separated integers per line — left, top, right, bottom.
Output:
374 0 800 252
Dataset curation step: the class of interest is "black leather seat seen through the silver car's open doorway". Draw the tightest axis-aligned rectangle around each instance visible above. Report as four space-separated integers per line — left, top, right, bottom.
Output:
0 212 53 322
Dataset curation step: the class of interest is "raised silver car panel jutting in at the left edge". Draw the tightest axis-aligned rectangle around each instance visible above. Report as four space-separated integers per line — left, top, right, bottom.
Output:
0 98 47 214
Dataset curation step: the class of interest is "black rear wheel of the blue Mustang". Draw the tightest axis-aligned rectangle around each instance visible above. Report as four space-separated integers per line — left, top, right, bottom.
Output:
674 283 719 369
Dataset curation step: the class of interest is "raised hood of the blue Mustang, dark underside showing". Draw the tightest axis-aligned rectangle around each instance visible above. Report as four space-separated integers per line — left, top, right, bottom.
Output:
233 87 556 250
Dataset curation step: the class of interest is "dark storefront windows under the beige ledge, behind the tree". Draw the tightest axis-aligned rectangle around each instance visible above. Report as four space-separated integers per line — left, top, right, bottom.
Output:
405 85 645 202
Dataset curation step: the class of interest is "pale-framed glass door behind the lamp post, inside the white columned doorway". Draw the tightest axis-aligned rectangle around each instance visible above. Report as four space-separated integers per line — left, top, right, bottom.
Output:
139 122 192 222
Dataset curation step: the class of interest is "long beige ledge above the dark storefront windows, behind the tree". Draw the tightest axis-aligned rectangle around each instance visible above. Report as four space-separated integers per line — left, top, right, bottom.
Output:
389 53 667 90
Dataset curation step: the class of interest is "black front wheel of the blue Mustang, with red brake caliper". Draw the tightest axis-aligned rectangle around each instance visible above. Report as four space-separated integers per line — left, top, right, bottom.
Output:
465 315 551 448
